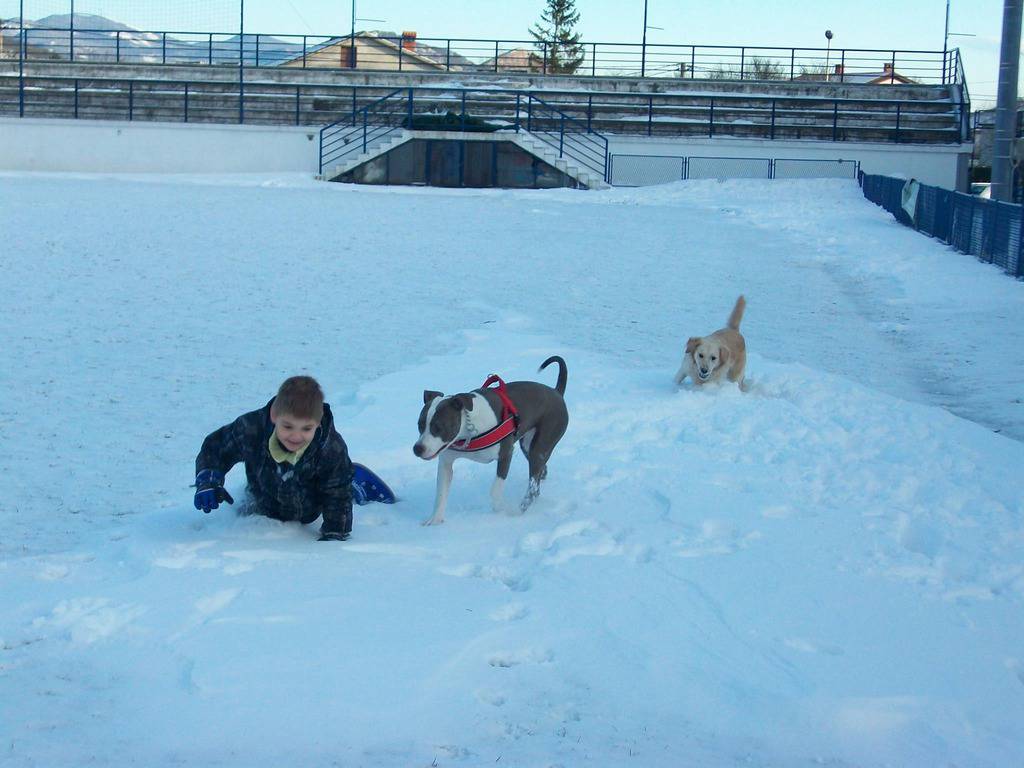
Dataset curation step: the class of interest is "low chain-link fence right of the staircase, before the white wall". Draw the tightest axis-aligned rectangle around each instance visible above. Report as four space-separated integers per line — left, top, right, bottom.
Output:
608 155 860 186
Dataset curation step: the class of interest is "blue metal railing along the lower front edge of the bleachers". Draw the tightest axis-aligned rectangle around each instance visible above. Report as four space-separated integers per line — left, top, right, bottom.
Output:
0 75 966 143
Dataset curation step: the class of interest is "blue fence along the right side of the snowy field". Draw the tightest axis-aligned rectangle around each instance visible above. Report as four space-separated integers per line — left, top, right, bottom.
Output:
859 174 1024 278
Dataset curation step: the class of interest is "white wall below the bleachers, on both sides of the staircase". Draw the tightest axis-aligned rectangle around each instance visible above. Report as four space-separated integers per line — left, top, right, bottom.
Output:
0 118 971 189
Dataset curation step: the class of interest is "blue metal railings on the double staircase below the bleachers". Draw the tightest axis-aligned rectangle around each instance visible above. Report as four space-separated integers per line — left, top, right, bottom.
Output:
319 88 608 181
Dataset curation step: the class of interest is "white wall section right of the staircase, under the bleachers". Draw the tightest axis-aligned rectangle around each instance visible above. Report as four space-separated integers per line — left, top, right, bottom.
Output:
608 136 972 189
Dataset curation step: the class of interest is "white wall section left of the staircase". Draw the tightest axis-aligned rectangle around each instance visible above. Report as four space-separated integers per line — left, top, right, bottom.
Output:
0 118 319 173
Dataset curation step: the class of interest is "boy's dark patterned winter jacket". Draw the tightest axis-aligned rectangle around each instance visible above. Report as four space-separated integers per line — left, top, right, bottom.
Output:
196 399 352 534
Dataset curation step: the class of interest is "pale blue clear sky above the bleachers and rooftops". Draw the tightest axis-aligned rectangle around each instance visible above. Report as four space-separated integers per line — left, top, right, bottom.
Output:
0 0 1015 106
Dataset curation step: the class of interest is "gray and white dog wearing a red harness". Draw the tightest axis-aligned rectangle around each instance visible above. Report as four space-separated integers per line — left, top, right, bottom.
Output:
413 355 569 525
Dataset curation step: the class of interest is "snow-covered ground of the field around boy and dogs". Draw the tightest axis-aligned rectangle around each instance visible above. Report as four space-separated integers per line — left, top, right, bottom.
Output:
0 174 1024 768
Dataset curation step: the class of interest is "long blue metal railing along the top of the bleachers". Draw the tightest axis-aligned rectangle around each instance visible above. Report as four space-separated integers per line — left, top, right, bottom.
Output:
6 19 955 84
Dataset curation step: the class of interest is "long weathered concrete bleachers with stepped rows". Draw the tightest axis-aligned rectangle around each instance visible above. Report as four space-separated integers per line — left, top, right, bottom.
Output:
0 61 969 144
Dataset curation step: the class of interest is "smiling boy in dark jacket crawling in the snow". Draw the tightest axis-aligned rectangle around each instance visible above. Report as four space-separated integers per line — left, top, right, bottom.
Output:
195 376 385 542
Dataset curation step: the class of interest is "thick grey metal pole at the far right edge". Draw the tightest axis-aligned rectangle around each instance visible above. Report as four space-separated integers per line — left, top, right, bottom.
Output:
991 0 1024 203
